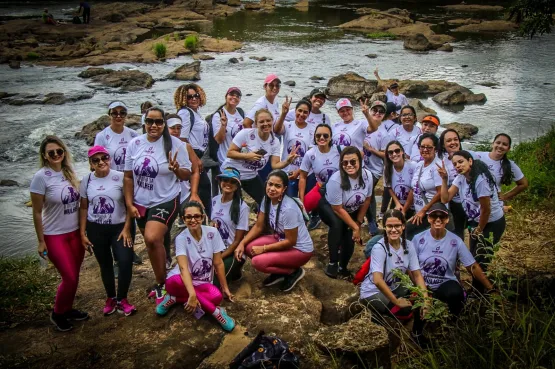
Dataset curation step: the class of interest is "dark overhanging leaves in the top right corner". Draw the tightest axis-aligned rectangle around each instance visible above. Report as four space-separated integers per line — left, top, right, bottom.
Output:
509 0 555 38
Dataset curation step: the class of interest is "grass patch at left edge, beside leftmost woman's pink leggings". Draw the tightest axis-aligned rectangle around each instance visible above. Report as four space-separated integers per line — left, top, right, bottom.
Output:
0 256 58 325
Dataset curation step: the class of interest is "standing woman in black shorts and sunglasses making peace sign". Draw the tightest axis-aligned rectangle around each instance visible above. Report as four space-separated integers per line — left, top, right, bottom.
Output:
124 107 191 301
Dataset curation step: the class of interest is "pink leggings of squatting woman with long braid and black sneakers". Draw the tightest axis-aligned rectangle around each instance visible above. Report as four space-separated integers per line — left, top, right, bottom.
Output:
245 236 312 274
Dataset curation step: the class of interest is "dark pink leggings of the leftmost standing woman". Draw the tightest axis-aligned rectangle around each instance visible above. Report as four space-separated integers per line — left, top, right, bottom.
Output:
44 230 85 314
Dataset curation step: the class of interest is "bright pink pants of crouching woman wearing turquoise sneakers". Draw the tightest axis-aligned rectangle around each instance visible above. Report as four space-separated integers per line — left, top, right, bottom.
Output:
166 274 223 314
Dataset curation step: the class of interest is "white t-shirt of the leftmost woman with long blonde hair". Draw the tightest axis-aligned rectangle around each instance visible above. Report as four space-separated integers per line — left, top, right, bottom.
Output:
31 167 81 235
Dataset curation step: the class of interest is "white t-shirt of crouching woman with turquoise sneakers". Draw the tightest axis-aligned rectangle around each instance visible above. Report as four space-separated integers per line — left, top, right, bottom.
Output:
168 225 225 286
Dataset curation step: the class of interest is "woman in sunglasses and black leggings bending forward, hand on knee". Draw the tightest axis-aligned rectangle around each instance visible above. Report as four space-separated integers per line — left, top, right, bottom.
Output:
318 146 373 278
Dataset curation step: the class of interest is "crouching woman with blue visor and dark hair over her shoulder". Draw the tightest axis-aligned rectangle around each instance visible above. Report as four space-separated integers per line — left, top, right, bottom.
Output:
210 168 249 286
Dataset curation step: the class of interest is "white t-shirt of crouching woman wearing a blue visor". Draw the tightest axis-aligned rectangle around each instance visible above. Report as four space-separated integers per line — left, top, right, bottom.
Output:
210 195 249 249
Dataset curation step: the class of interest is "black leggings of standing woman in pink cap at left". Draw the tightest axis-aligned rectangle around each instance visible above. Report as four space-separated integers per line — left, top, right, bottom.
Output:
86 221 133 299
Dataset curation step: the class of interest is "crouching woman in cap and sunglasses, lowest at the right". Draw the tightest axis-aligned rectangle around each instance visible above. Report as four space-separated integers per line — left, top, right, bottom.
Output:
412 203 493 315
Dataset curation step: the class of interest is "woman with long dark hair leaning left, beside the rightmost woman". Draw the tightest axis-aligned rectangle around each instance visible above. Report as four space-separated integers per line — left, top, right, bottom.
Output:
438 150 506 290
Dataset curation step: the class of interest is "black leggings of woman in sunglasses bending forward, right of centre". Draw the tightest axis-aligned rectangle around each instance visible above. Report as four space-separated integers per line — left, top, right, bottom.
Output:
318 196 356 269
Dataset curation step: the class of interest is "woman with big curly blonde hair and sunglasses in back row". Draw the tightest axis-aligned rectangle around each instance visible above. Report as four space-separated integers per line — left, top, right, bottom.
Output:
173 83 212 214
